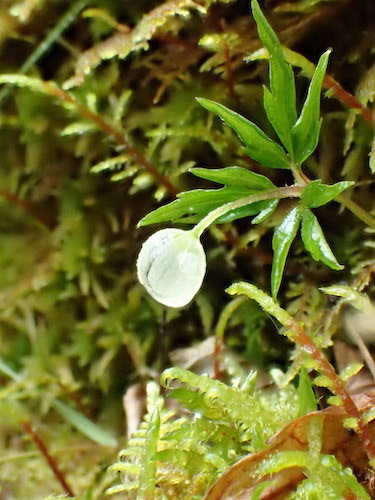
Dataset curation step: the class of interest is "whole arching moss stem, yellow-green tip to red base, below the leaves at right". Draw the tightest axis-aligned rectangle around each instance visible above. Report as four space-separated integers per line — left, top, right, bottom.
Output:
227 282 375 466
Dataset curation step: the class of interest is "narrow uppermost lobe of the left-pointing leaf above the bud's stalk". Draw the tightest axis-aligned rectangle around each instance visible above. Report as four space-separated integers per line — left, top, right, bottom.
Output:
190 167 276 190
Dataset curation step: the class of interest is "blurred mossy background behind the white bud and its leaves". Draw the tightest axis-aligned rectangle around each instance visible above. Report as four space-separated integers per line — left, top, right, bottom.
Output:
0 0 375 499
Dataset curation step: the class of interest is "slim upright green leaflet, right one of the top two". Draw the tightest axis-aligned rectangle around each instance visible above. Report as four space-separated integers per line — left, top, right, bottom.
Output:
292 50 331 165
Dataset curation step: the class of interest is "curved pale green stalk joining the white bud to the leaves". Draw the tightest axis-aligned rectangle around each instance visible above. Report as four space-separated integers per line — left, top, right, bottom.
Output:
191 185 303 238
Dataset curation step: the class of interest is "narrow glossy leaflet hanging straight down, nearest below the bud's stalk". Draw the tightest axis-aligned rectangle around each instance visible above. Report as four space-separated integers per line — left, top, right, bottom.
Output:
271 206 302 298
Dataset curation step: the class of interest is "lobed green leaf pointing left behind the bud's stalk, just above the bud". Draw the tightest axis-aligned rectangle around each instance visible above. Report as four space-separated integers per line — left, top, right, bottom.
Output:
138 167 276 226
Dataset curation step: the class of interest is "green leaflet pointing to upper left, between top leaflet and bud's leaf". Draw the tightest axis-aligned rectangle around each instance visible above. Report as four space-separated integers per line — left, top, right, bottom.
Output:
197 98 289 168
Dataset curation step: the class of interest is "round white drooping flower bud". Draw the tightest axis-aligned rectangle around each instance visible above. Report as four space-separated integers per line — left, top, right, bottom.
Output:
137 228 206 307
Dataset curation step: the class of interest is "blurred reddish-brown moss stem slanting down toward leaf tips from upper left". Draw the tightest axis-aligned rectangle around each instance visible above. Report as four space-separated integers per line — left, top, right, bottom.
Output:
43 82 177 196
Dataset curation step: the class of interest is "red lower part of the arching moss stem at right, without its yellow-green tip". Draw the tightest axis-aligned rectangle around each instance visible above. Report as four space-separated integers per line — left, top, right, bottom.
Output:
284 319 375 460
